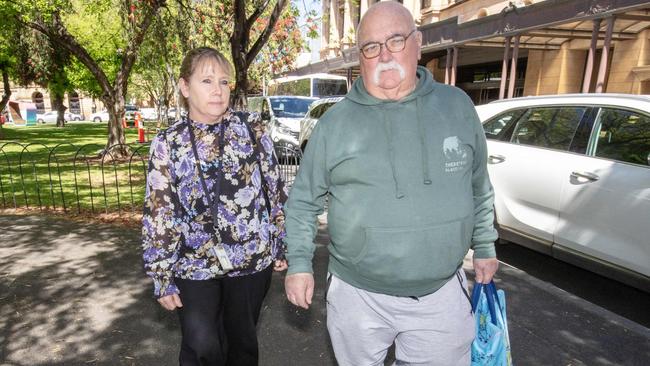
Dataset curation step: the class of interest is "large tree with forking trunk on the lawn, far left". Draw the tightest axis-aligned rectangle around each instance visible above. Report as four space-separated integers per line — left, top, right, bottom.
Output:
0 0 165 156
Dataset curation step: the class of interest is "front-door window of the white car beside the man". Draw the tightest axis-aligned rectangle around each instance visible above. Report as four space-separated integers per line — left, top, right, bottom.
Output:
511 107 587 150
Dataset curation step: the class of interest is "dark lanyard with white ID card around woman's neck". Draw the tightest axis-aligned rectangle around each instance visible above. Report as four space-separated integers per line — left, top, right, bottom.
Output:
186 118 234 272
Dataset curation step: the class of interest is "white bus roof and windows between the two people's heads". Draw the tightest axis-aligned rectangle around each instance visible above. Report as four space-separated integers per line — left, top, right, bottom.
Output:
266 74 348 98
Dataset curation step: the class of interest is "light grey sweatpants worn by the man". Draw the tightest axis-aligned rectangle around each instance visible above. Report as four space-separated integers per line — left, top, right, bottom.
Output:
327 269 474 366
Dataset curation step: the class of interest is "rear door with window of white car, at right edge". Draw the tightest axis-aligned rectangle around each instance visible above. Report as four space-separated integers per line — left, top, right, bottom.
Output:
555 107 650 276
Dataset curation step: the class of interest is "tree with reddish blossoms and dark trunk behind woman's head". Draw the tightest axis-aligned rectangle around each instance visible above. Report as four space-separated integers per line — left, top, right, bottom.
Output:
134 0 304 114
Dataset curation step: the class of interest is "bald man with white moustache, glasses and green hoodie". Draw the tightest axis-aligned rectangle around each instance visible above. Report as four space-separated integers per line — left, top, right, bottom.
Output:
285 2 498 366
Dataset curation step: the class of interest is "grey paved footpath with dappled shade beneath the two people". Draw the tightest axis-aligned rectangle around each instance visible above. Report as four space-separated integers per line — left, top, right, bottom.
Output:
0 214 650 366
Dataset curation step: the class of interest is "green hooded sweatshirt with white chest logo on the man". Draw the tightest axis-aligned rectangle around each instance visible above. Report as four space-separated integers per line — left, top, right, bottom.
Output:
284 67 497 296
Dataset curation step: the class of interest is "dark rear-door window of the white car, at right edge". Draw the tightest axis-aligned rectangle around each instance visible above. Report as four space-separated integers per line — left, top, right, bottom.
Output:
595 108 650 166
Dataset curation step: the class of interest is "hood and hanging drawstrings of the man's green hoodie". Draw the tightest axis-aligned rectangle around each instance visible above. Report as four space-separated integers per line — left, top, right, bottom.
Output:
345 66 436 199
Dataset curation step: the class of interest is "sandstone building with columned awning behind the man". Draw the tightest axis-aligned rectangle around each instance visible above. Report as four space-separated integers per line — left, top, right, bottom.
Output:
290 0 650 104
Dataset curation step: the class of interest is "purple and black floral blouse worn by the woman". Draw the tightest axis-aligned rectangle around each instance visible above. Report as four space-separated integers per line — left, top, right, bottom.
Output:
142 110 287 297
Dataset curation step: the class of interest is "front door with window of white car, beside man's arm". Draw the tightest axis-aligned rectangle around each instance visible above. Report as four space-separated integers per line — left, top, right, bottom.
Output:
484 106 589 250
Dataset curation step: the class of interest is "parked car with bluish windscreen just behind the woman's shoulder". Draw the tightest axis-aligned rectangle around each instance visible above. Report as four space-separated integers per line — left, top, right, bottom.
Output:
248 95 318 159
